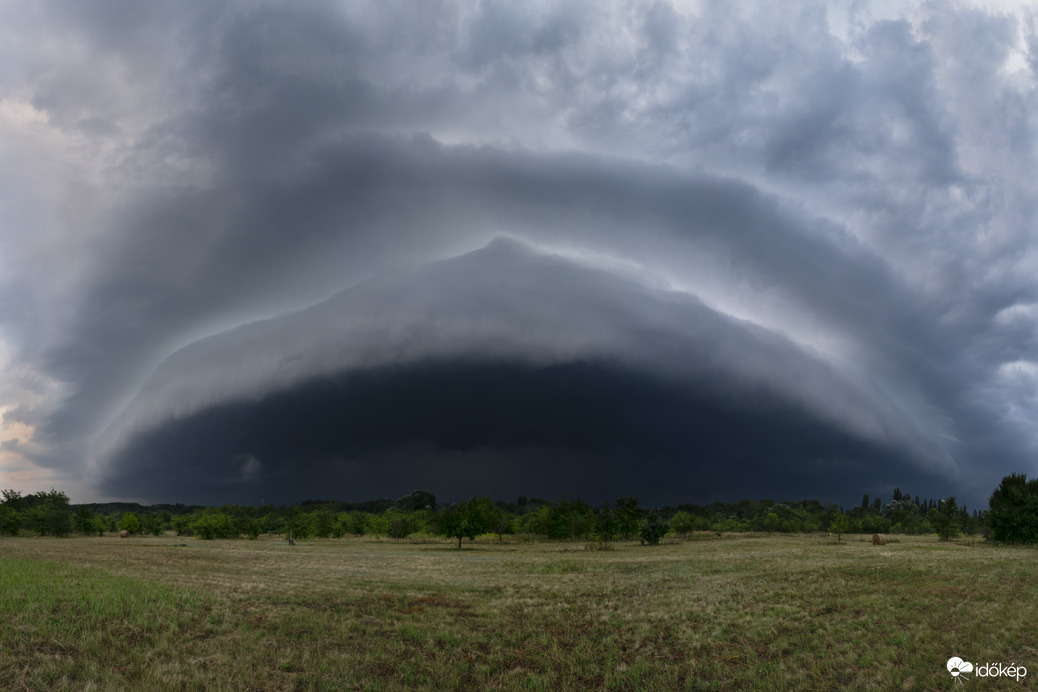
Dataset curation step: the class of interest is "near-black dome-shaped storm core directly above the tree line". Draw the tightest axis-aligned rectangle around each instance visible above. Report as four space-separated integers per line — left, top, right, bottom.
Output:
105 360 953 504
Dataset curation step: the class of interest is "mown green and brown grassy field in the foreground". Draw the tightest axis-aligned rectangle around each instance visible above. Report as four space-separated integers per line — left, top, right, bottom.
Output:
0 534 1038 691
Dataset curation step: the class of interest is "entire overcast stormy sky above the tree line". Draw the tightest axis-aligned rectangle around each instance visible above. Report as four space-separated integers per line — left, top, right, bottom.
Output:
0 0 1038 508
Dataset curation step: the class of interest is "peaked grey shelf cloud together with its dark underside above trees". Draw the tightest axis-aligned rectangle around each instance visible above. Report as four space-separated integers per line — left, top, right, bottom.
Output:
97 239 954 501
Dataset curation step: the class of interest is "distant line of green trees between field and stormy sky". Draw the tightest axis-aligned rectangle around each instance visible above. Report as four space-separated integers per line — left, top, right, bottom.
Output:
0 474 1038 547
